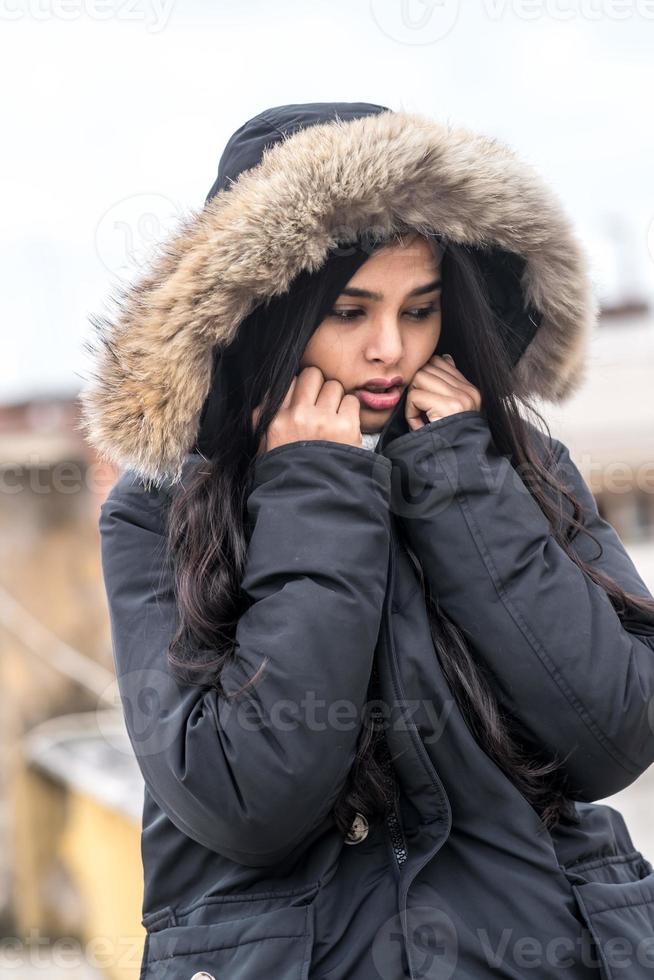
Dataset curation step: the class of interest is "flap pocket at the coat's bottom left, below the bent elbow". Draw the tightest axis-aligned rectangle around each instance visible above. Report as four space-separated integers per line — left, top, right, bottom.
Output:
141 904 314 980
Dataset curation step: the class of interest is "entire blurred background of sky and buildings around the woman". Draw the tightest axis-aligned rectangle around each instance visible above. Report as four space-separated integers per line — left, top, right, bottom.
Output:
0 0 654 980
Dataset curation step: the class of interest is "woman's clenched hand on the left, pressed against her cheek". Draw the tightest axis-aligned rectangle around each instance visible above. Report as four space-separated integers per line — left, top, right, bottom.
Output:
252 365 362 456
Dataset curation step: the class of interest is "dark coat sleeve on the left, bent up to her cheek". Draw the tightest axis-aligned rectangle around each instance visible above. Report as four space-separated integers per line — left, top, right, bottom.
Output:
99 440 391 867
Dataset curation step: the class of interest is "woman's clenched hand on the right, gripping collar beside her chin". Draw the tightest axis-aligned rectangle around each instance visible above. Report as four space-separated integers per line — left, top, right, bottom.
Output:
404 354 481 429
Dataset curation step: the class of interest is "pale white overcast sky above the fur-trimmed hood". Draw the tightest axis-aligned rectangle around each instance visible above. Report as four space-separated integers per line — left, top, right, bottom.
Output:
0 0 654 401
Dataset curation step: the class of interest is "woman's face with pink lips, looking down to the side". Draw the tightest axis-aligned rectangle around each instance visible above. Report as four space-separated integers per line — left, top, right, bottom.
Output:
300 235 441 432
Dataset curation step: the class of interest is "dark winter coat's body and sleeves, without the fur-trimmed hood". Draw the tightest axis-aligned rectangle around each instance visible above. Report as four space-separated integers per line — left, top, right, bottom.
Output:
100 390 654 980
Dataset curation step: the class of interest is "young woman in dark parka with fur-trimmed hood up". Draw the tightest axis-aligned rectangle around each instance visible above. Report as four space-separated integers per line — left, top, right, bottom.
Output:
82 103 654 980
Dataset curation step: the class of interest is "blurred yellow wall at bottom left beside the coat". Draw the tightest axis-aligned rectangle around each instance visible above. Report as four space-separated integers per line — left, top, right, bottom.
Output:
11 756 145 980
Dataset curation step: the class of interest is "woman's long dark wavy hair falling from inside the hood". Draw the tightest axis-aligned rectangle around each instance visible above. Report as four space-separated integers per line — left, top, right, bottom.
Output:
168 230 654 835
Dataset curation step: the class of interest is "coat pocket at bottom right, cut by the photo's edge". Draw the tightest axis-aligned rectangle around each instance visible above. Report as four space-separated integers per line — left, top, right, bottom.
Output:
562 828 654 980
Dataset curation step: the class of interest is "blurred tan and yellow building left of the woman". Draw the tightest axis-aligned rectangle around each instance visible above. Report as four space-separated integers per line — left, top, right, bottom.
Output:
0 398 133 980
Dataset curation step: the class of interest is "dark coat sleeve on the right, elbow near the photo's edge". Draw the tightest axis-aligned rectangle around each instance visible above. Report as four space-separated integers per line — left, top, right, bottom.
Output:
384 410 654 802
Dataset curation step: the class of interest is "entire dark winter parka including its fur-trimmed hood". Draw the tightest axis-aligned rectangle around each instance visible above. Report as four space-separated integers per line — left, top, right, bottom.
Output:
82 103 654 980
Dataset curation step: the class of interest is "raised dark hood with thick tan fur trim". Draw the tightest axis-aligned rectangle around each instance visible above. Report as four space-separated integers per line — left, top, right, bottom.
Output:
78 103 598 483
